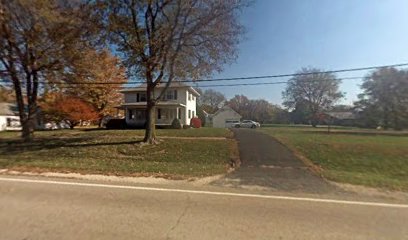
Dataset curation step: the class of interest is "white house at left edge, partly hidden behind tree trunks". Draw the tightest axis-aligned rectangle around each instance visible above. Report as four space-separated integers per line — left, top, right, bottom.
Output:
0 102 44 131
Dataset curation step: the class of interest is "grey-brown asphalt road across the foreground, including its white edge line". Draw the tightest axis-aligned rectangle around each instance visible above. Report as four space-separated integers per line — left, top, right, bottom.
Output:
0 176 408 240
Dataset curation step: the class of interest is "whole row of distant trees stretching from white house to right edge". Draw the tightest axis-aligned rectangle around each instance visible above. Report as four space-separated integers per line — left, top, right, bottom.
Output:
198 68 408 130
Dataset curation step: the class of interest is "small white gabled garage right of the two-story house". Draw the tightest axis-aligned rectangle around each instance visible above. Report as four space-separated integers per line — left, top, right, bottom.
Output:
206 105 242 128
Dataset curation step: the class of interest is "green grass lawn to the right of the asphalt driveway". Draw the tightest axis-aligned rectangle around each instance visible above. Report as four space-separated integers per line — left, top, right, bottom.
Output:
259 127 408 191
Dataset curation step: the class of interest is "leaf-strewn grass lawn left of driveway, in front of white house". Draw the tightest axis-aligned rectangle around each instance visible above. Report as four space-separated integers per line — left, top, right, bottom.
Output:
0 128 237 178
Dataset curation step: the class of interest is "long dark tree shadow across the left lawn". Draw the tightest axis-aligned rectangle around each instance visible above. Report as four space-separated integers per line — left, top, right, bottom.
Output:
0 137 142 155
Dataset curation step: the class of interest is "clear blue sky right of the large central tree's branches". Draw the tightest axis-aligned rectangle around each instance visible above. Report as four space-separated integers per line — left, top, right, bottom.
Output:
194 0 408 104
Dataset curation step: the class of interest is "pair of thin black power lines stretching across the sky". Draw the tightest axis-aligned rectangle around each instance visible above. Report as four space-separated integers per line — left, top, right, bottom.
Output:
0 63 408 87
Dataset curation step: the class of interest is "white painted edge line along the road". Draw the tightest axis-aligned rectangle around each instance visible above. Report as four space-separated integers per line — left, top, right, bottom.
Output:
0 177 408 208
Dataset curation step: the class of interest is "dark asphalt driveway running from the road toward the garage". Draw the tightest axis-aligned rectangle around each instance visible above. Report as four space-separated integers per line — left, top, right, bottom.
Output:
215 129 339 193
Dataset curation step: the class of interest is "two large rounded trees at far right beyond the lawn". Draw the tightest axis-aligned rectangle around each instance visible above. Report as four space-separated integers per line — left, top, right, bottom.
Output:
283 68 408 130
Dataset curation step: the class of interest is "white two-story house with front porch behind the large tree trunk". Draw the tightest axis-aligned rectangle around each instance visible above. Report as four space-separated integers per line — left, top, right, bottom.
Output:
121 82 200 127
